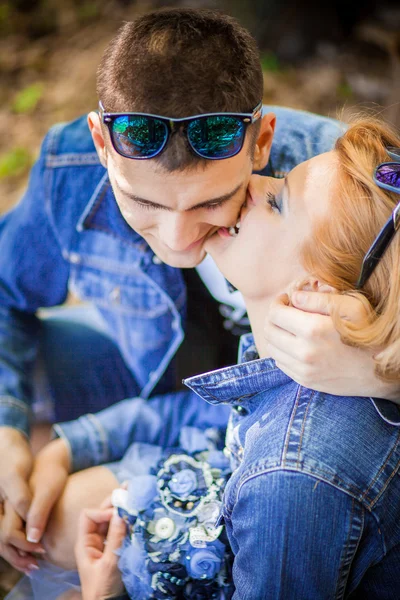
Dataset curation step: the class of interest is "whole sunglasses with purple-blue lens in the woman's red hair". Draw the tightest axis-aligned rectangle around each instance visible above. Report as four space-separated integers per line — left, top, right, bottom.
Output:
356 147 400 289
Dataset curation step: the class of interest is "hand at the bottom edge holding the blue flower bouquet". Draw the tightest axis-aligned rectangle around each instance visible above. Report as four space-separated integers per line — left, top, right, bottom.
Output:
75 508 126 600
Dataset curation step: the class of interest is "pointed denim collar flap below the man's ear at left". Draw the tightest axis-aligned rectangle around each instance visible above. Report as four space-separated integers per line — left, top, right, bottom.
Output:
77 171 149 252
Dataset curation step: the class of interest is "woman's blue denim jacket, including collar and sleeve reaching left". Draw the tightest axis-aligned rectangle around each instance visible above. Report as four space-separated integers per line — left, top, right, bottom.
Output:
56 335 400 600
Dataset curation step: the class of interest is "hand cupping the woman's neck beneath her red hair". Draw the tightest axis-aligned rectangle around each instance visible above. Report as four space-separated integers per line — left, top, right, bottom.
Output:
264 291 400 402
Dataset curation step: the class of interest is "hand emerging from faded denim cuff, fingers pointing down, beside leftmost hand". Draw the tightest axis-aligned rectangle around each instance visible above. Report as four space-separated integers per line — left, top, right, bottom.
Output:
26 439 71 542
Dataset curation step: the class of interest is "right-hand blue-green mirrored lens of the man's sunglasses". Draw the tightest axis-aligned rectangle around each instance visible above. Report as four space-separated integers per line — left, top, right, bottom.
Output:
187 116 245 158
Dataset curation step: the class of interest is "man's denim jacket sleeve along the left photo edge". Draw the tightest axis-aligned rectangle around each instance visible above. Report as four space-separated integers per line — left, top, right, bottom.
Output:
0 135 68 434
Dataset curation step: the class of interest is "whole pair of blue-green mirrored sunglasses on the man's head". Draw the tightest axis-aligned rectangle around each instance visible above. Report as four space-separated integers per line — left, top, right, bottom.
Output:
99 101 262 160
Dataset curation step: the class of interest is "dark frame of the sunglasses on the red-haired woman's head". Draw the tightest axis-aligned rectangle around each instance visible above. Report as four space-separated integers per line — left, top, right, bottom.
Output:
356 147 400 290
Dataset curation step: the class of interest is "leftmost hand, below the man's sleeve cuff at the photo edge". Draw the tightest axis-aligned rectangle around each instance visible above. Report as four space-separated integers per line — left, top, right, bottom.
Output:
0 427 43 573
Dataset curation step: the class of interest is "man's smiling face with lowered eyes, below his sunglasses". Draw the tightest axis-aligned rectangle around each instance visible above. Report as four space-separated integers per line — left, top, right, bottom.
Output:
107 141 252 268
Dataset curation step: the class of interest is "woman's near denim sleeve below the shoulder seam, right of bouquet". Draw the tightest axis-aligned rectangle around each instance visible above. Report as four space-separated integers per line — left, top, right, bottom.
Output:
227 468 363 600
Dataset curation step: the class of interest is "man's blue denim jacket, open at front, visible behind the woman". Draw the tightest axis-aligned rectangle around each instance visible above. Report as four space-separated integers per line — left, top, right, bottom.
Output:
0 107 341 432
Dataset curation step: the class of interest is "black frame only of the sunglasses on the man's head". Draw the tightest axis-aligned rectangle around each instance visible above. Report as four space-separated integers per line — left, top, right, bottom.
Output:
99 100 262 160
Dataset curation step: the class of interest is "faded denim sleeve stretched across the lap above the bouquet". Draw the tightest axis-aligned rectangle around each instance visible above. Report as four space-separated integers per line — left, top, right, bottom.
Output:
54 390 230 472
